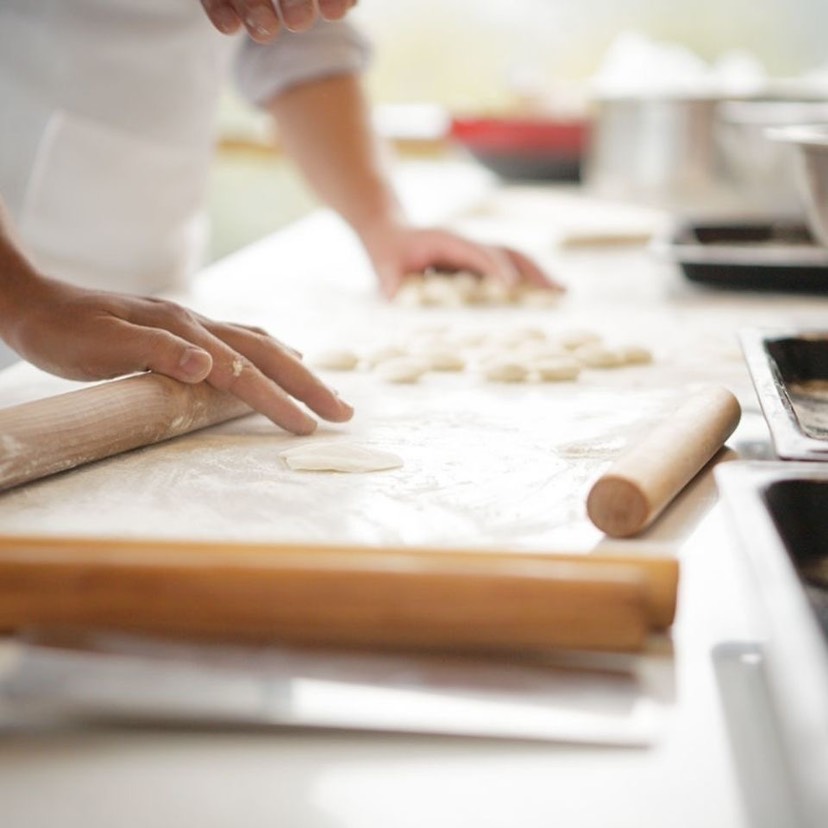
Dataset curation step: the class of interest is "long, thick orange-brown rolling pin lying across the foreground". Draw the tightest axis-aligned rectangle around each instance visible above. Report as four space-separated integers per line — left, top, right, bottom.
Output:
0 538 674 652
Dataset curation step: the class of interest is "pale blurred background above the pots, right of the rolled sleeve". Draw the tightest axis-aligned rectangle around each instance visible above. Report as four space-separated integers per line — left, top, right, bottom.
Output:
355 0 828 108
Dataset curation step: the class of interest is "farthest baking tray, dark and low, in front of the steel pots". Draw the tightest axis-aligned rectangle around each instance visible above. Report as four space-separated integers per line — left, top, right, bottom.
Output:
670 221 828 293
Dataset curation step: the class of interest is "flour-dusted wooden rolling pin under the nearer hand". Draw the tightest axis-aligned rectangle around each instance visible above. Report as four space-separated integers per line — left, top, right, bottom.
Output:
0 374 250 490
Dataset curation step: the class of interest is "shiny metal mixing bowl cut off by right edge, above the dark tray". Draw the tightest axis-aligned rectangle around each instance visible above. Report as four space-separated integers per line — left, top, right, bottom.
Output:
768 124 828 247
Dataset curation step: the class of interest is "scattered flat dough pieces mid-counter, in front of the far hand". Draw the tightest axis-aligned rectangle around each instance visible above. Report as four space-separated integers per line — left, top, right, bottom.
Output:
310 327 653 383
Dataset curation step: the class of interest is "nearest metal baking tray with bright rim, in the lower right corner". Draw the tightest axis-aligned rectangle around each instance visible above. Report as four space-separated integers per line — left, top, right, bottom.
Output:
716 463 828 828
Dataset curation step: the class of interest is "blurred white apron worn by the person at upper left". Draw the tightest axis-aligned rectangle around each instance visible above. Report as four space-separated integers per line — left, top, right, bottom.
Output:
0 0 232 293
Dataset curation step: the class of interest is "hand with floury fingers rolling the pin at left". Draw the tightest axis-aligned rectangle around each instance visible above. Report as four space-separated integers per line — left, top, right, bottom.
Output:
4 277 353 434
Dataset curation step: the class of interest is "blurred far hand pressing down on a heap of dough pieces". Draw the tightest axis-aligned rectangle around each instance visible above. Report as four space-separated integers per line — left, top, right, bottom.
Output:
365 226 563 299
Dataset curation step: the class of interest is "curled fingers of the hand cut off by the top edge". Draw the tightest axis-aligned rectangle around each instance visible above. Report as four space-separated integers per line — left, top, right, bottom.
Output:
201 0 356 43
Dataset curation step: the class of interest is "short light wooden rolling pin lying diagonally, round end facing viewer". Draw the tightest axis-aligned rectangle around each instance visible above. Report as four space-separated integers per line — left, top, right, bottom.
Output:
587 387 741 538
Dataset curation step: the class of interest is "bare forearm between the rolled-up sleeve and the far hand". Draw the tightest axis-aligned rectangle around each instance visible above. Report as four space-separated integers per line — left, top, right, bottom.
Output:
268 75 404 248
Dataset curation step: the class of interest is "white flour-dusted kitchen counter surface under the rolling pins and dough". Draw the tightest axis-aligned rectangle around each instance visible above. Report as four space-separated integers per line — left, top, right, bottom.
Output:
0 166 828 828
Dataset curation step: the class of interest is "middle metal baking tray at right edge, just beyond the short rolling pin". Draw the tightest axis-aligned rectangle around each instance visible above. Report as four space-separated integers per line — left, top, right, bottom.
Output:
739 328 828 461
